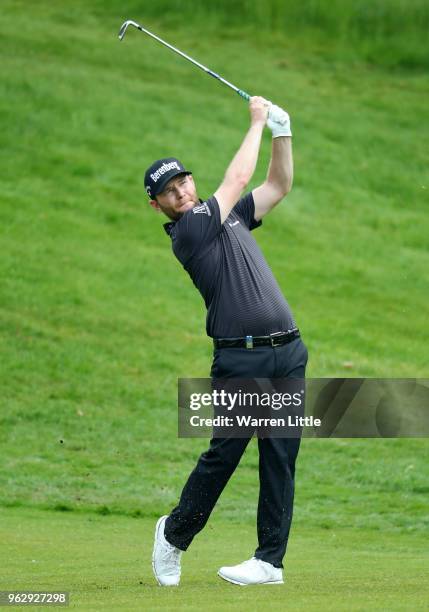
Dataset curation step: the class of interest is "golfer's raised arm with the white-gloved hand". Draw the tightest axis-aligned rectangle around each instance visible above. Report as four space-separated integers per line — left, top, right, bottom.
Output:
252 109 293 221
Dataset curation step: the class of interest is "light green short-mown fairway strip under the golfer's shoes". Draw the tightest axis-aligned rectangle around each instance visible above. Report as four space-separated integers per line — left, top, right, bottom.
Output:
0 509 429 612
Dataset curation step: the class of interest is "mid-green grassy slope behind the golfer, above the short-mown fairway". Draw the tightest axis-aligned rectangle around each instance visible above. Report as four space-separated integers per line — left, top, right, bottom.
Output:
0 3 428 516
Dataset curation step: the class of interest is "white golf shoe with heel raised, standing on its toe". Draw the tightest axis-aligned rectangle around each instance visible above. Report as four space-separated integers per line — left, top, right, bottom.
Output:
152 516 182 586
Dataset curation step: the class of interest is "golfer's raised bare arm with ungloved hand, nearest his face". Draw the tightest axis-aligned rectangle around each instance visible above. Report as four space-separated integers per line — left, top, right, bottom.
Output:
214 96 269 223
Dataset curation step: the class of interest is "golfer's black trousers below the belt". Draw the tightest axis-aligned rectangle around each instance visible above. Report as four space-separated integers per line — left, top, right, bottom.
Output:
165 338 308 567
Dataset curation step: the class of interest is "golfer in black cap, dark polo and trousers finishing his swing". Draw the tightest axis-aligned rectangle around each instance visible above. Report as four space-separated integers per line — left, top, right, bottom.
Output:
145 96 308 586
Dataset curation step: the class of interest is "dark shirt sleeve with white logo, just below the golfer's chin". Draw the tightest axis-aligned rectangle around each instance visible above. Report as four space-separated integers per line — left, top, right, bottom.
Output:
172 196 222 265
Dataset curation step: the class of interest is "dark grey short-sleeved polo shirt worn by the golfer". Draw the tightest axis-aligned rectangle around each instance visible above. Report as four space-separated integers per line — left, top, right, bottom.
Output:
164 193 296 338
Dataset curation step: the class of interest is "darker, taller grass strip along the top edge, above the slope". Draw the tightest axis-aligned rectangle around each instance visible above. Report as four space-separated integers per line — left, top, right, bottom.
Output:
95 0 429 70
